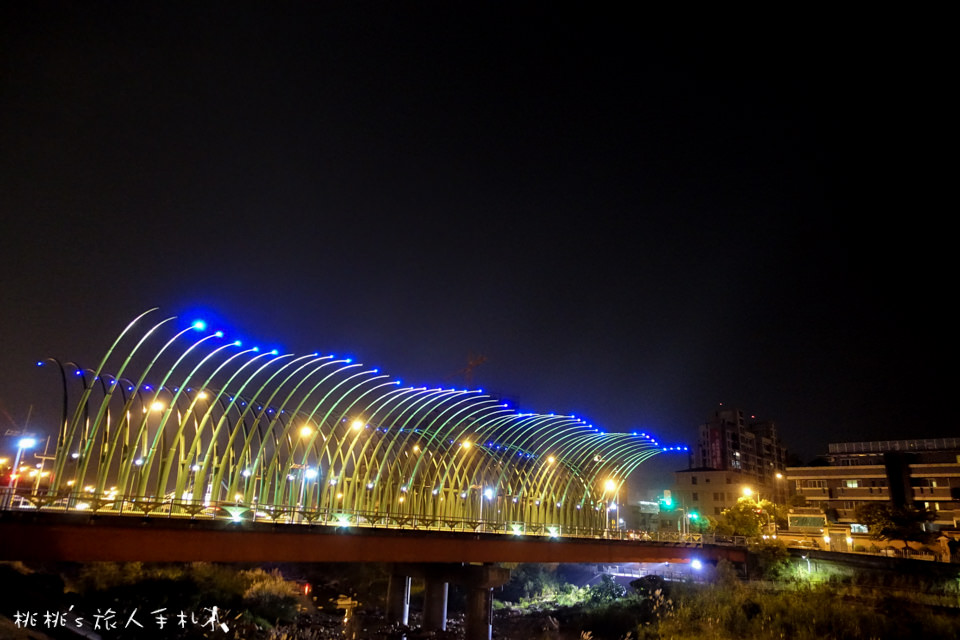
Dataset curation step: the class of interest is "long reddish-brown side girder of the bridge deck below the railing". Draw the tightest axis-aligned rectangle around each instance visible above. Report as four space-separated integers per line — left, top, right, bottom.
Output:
0 512 746 563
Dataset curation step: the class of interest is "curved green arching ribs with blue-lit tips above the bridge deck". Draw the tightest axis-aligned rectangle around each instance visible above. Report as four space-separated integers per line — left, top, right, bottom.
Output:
9 311 683 535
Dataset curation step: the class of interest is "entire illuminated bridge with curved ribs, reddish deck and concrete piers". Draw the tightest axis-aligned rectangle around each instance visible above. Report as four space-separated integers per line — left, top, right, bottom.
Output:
0 310 728 637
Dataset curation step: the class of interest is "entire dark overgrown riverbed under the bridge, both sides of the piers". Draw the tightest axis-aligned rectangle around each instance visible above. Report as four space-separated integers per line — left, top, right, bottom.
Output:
7 548 960 640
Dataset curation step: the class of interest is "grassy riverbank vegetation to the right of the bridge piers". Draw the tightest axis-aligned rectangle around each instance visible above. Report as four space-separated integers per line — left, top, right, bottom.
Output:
499 563 960 640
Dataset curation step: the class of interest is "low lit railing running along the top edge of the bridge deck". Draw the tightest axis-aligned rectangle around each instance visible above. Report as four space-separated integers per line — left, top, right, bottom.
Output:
0 488 720 546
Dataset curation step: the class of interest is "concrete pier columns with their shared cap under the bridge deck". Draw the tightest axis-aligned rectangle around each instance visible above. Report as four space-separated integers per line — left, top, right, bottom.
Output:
387 563 510 640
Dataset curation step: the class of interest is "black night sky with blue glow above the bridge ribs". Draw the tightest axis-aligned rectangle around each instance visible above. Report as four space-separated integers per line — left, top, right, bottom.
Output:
0 2 956 467
